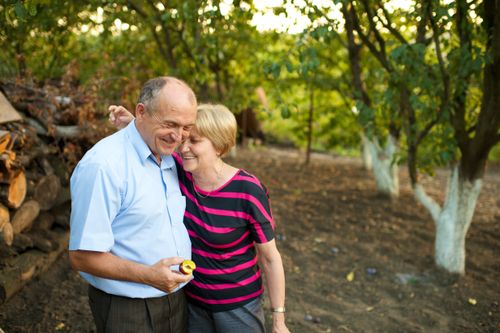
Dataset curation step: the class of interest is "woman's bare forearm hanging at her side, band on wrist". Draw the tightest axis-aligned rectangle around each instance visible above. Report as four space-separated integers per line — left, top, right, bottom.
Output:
255 239 290 333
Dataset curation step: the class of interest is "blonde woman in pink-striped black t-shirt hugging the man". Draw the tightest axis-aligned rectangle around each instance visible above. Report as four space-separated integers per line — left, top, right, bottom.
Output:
110 104 289 333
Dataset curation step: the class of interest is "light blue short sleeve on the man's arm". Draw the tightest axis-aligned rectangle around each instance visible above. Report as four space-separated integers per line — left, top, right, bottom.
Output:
69 163 121 252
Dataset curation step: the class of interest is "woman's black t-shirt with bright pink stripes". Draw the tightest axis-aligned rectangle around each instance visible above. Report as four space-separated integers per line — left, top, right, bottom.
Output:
174 154 274 312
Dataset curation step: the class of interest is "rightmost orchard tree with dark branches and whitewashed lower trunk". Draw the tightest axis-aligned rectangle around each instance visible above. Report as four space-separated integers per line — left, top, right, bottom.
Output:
412 0 500 274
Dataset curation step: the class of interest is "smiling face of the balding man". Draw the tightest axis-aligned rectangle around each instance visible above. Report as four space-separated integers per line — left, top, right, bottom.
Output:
136 86 196 158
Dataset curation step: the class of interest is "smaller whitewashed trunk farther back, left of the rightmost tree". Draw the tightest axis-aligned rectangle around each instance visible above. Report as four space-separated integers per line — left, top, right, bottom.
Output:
366 135 399 198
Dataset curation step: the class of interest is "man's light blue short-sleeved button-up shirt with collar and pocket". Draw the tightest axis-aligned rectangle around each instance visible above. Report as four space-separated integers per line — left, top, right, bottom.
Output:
69 122 191 298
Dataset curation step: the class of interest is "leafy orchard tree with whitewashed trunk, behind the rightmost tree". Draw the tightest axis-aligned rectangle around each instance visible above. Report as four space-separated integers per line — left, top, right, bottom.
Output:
299 1 400 198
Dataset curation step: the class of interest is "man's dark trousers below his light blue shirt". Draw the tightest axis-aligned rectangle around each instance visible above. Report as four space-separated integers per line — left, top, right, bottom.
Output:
89 285 187 333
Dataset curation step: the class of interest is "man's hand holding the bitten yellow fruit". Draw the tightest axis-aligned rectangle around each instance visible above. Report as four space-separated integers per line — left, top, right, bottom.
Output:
147 257 191 293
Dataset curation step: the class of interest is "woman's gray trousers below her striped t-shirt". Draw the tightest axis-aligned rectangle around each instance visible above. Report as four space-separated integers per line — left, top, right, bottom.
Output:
188 297 266 333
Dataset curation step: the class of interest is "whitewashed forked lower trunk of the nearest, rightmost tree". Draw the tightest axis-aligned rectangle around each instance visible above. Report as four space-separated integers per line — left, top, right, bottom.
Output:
414 166 482 274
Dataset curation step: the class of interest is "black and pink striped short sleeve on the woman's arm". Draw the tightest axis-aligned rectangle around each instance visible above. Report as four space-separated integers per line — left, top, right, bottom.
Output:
248 180 274 243
